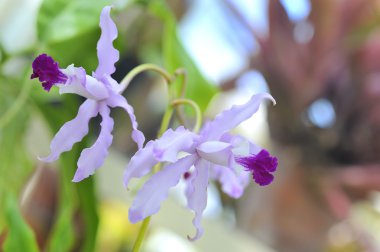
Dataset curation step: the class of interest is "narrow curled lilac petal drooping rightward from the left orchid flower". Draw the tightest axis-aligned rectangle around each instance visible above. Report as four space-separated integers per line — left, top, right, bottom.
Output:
107 94 145 149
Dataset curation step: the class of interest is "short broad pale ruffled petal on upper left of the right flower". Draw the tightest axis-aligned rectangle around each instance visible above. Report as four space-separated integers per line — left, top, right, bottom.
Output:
153 126 198 163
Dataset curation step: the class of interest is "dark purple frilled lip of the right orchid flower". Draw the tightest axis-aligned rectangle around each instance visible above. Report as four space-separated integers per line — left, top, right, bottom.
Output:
235 149 278 186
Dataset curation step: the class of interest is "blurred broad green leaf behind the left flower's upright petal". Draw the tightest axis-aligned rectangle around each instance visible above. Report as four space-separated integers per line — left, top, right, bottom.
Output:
37 0 110 73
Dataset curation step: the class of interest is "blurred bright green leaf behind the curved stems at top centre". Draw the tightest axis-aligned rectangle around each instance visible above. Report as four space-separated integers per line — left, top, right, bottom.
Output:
150 1 218 110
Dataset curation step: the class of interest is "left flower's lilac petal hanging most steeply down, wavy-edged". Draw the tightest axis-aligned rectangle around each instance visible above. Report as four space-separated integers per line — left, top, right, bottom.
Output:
73 104 114 182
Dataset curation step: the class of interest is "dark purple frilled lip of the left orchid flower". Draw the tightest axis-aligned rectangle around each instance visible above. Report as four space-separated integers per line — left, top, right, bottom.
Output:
30 54 68 92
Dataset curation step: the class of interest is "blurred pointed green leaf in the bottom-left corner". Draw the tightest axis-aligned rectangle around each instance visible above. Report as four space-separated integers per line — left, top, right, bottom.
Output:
3 193 39 252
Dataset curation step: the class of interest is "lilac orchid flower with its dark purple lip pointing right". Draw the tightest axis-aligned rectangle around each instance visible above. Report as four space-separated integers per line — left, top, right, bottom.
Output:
124 93 277 240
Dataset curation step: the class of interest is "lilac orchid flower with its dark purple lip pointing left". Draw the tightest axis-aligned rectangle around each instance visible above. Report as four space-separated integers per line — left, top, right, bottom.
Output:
31 6 145 182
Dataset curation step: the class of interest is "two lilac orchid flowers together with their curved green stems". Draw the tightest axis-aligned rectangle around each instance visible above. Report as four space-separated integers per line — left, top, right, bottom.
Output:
31 6 278 251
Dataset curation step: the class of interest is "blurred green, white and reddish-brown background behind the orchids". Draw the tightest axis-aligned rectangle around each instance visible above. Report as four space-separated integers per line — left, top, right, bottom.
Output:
0 0 380 252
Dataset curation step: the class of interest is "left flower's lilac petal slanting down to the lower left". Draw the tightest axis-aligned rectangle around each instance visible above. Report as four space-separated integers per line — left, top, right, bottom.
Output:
40 99 98 162
